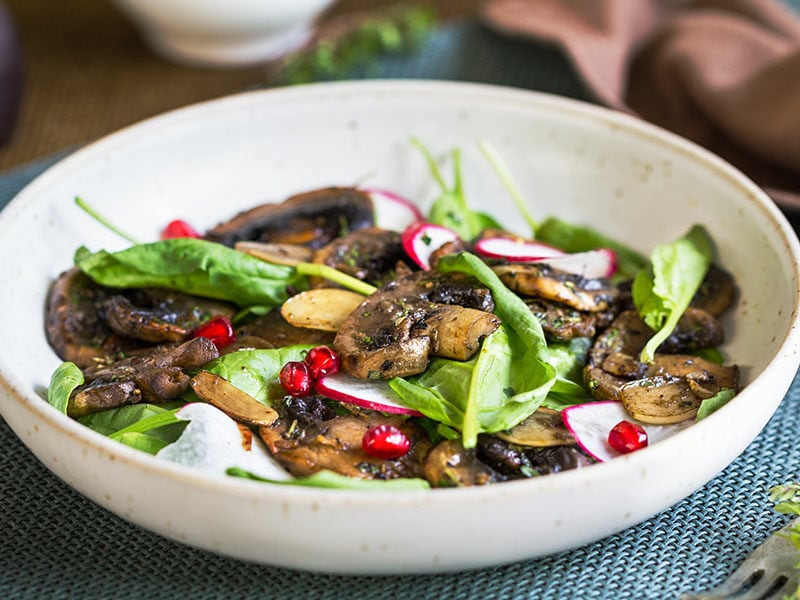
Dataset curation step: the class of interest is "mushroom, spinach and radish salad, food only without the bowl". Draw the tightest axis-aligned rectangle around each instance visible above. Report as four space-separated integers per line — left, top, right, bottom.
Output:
46 140 739 489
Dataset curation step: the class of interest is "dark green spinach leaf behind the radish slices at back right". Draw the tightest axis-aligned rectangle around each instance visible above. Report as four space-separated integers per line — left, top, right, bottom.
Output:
536 217 648 279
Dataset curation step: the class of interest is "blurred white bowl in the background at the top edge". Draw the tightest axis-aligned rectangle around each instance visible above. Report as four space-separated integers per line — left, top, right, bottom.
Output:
108 0 333 67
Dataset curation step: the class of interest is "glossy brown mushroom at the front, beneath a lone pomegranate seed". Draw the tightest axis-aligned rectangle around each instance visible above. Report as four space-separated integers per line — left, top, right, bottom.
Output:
259 397 430 479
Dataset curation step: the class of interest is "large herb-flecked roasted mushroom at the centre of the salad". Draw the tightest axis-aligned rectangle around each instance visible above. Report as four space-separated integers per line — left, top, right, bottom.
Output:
333 272 500 379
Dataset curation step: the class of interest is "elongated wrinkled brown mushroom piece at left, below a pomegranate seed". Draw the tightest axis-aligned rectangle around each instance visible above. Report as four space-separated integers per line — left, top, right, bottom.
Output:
67 337 219 417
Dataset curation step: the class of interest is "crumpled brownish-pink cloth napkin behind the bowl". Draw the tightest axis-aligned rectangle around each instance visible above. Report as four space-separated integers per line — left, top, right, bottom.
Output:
483 0 800 210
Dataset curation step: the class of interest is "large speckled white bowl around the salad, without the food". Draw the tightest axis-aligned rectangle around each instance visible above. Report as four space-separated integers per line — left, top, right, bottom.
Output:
0 81 800 574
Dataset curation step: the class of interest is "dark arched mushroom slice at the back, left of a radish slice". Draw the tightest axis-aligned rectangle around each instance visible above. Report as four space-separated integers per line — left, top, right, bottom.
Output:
206 187 374 249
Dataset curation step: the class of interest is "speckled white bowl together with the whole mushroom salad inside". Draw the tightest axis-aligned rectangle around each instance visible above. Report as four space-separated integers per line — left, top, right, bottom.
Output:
0 81 800 574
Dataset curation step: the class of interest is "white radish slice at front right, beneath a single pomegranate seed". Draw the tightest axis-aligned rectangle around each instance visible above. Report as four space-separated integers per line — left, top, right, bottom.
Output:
561 400 692 462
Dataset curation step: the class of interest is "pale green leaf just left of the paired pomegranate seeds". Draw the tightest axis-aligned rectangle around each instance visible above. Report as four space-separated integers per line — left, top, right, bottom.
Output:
203 344 313 405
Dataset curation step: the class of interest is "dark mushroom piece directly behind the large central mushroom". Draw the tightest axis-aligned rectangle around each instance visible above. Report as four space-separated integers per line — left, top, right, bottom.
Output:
311 227 408 287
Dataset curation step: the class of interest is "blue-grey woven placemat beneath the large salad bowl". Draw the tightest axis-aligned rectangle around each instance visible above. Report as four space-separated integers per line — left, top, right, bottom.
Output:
0 16 800 600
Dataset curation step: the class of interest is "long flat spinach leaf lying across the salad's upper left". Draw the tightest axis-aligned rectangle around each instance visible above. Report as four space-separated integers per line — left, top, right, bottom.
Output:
74 238 304 306
